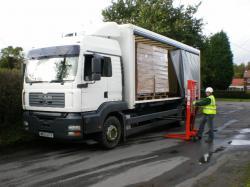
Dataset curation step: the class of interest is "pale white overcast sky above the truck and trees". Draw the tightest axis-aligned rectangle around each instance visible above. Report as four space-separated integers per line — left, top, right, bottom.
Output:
0 0 250 64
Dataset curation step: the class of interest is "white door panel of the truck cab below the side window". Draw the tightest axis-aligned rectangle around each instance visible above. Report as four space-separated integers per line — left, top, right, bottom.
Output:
82 54 108 111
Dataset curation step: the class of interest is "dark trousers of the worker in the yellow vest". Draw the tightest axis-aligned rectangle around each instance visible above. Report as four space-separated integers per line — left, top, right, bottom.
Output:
198 114 214 140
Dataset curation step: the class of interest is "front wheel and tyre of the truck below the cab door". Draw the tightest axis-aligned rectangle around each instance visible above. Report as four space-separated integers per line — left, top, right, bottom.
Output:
99 116 121 149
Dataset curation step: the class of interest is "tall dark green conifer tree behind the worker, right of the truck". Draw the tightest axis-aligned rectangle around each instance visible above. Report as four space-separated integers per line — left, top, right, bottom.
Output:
202 31 234 90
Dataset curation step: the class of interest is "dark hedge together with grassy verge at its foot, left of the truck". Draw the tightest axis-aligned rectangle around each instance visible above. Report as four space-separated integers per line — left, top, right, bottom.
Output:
0 68 32 148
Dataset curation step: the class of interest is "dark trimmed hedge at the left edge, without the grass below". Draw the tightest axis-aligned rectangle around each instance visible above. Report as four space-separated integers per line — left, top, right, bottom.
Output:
0 68 22 128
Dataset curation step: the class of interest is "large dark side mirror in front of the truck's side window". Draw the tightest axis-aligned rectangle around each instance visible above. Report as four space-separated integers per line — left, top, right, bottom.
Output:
91 54 103 81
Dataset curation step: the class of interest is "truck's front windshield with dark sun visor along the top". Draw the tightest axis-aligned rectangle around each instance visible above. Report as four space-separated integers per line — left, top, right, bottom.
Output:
25 46 79 83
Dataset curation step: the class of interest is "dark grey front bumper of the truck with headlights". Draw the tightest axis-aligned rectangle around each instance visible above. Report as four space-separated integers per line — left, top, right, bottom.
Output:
23 111 83 140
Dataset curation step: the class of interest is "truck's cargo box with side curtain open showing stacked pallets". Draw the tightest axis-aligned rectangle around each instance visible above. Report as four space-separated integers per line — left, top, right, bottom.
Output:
116 24 200 109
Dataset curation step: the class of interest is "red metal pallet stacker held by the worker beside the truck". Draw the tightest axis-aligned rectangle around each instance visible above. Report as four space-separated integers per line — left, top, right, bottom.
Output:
165 80 199 140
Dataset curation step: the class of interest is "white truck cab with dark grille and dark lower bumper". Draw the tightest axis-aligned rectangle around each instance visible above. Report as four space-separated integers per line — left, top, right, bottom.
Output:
23 32 122 142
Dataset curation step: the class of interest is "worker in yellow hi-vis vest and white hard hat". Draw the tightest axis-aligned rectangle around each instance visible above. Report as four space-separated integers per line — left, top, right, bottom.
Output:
193 87 216 143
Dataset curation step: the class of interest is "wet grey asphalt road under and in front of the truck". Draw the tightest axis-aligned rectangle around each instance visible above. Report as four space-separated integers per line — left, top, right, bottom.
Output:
0 102 250 187
